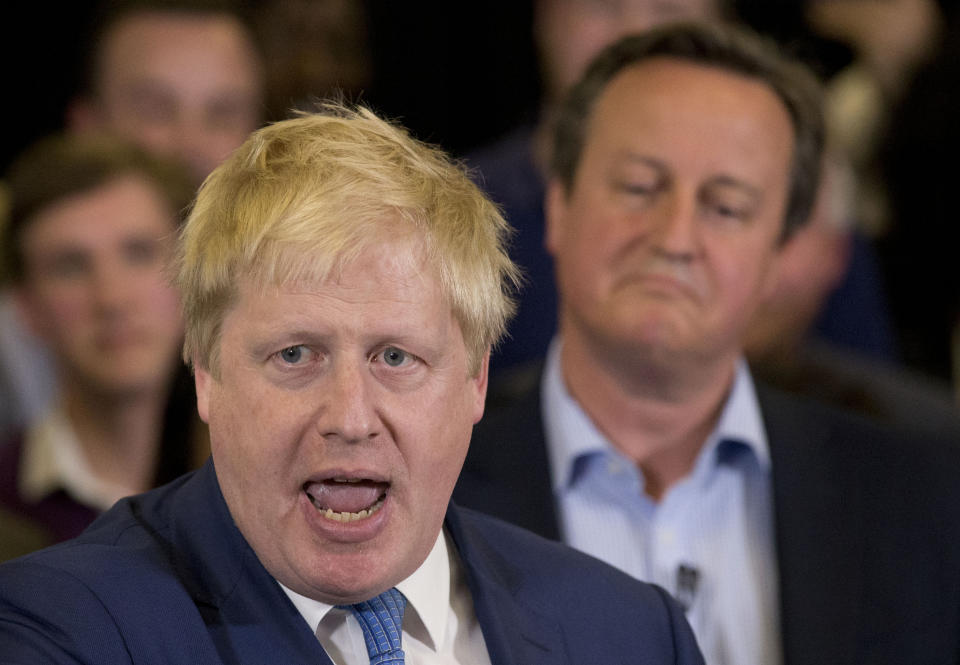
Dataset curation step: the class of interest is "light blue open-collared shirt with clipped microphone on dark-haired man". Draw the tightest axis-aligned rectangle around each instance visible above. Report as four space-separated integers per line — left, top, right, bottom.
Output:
542 340 782 665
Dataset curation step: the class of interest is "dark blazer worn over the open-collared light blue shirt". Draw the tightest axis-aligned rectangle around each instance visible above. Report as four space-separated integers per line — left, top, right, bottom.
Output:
453 368 960 665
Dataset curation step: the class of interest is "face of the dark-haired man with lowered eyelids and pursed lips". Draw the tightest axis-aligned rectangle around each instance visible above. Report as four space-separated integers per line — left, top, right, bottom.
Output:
547 58 793 367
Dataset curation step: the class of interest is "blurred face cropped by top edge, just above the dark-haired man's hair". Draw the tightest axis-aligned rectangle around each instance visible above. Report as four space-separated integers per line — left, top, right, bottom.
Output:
537 0 720 100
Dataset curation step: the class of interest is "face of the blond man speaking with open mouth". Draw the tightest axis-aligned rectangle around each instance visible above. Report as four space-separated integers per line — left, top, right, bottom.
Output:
196 235 486 603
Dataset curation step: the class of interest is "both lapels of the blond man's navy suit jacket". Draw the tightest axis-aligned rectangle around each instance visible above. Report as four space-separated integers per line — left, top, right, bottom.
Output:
172 463 569 665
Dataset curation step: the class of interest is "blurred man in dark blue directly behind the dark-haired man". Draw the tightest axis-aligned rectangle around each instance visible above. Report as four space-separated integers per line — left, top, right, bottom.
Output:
469 0 726 373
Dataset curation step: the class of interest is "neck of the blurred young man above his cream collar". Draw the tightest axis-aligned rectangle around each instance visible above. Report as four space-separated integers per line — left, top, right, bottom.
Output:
64 378 166 494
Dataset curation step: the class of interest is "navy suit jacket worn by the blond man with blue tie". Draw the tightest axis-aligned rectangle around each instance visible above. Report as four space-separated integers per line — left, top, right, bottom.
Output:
0 463 703 665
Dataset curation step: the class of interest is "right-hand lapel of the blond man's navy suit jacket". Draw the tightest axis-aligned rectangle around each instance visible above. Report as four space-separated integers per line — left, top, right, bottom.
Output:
446 504 569 665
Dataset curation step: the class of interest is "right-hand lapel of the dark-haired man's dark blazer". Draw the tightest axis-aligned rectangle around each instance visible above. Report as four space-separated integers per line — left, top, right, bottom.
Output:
758 387 865 665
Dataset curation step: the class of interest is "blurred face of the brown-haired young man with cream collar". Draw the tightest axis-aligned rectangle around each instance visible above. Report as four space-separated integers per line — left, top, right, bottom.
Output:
20 176 183 394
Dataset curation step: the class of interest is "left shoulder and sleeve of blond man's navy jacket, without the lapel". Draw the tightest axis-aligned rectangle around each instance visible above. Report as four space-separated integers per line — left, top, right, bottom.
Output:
0 470 234 665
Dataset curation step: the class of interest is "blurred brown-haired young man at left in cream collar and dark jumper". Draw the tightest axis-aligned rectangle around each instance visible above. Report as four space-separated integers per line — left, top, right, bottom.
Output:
0 135 204 558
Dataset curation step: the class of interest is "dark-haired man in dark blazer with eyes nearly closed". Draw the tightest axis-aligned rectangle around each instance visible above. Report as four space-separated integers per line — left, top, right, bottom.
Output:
454 24 960 665
